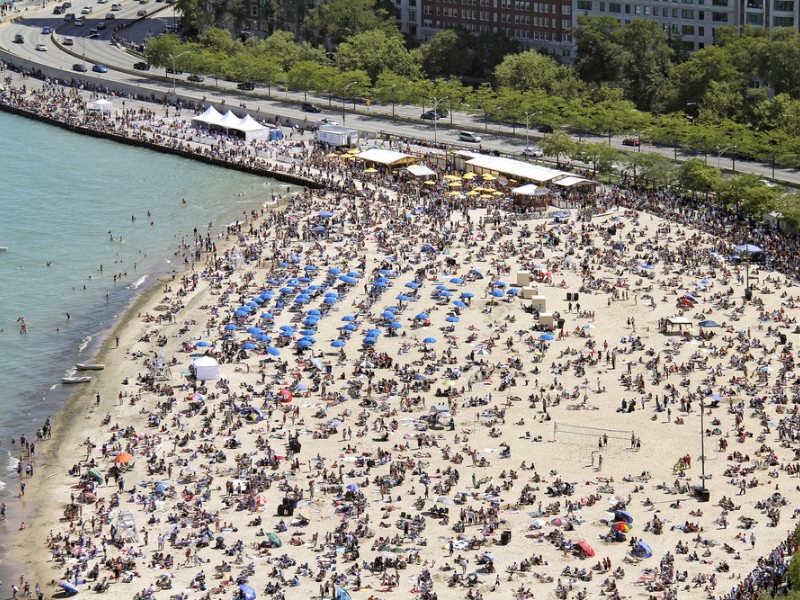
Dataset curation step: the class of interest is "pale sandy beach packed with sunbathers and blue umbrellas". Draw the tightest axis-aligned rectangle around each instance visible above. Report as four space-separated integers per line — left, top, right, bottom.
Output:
3 75 800 600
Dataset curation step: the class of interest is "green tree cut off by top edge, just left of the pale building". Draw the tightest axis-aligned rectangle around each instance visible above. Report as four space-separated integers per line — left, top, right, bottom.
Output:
302 0 400 45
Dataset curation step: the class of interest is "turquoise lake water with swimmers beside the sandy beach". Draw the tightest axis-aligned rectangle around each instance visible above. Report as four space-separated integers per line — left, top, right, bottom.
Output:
0 113 286 496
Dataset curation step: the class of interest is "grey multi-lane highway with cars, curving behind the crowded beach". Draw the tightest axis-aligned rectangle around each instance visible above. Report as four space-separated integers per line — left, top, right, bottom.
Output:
0 0 800 186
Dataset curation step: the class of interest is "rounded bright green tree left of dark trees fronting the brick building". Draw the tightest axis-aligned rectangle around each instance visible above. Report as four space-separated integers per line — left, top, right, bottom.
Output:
336 29 420 81
